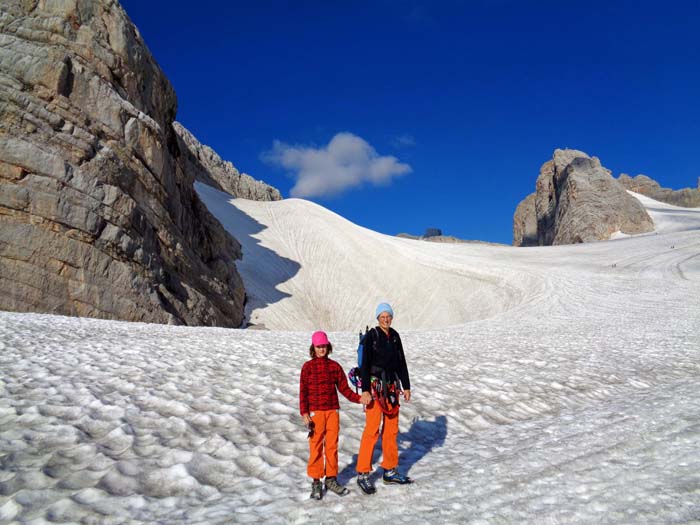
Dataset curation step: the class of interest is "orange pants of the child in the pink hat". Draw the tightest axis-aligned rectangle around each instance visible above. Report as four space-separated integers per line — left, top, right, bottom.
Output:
306 410 340 479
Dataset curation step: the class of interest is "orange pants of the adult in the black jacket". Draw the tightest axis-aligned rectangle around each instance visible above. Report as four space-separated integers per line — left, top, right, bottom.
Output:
355 400 399 472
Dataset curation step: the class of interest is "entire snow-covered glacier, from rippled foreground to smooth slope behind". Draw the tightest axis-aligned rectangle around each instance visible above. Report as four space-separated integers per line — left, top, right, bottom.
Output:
0 186 700 524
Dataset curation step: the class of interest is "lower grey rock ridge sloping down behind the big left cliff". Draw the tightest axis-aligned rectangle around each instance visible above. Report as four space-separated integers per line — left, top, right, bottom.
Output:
173 122 282 201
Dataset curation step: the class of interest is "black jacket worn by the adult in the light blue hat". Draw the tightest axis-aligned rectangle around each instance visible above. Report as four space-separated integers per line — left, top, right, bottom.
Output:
360 326 411 392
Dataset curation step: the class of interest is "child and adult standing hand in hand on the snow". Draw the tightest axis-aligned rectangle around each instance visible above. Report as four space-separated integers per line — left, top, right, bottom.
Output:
299 303 411 499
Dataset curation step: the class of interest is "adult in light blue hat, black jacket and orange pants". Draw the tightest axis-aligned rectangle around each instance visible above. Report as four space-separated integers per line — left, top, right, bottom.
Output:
356 303 411 494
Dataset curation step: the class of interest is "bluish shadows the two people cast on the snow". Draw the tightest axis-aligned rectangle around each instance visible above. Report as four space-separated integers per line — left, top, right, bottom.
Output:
338 416 447 485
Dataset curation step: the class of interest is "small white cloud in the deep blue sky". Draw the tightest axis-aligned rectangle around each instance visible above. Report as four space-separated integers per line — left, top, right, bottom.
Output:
263 132 412 197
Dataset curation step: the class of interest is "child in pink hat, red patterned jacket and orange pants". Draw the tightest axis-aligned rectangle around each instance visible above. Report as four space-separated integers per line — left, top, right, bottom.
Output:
299 332 360 499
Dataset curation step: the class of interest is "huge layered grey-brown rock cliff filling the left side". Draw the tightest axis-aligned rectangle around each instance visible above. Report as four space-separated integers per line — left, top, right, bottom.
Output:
0 0 244 326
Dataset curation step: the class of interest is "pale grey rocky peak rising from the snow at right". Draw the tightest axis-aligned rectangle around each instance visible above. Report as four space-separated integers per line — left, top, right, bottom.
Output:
513 149 654 246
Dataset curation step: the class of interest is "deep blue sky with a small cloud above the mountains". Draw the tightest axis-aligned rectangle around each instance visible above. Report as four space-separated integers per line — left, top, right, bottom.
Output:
122 0 700 244
